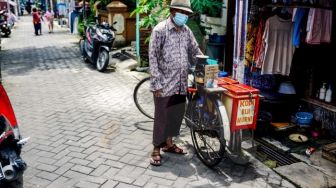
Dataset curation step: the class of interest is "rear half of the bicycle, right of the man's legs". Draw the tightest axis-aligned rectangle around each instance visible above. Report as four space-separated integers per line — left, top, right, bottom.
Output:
184 64 229 167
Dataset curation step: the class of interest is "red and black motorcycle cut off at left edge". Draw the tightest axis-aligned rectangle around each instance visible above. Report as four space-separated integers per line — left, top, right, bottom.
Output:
0 83 29 188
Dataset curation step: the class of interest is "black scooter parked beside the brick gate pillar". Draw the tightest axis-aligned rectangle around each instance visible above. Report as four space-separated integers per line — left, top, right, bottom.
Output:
79 19 117 72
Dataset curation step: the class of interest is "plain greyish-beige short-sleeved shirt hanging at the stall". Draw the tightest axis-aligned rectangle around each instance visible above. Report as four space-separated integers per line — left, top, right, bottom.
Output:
261 15 295 76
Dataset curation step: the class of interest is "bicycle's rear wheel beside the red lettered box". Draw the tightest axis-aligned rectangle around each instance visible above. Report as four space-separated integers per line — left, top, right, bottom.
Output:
186 99 225 167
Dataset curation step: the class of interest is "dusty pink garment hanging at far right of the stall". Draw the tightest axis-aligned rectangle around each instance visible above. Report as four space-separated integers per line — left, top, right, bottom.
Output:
306 8 332 44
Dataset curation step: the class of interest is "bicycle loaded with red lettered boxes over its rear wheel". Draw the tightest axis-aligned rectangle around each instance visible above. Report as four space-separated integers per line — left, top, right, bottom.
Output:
133 57 259 167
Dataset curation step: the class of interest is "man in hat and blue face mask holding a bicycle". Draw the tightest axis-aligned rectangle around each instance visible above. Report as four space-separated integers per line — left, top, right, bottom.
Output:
149 0 202 166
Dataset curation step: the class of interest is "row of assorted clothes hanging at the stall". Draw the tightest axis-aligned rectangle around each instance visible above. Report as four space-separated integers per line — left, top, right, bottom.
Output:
239 0 332 86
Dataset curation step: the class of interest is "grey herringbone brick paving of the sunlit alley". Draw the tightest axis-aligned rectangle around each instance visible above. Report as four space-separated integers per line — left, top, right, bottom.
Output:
0 17 293 188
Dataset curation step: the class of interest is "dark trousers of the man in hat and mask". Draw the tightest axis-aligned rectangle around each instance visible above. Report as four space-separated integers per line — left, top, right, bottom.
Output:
153 95 186 147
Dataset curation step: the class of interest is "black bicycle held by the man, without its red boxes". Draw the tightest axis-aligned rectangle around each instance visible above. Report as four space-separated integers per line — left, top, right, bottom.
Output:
133 63 253 167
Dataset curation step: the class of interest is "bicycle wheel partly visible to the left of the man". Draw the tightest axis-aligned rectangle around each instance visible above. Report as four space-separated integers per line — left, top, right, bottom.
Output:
133 77 154 119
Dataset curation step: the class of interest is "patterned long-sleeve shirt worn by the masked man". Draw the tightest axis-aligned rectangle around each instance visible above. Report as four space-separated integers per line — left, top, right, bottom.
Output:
149 17 202 97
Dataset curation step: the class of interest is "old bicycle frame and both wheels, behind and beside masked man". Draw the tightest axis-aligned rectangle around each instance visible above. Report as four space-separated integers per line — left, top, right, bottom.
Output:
133 69 228 167
